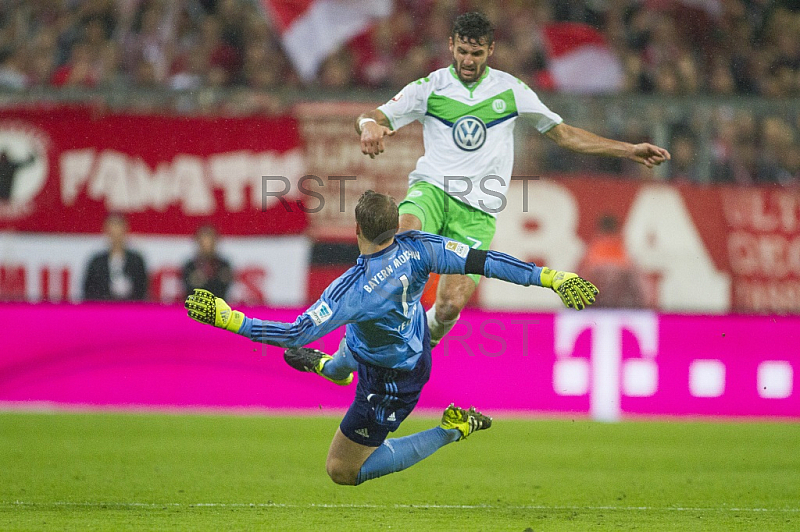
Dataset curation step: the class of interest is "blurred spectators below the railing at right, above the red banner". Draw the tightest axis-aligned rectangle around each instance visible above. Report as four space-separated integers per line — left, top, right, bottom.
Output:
517 100 800 187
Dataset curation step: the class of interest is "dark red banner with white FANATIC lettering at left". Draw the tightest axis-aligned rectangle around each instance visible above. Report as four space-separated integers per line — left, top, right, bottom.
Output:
0 107 307 235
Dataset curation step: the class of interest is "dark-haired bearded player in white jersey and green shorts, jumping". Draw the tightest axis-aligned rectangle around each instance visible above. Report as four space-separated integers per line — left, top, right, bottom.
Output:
356 12 670 346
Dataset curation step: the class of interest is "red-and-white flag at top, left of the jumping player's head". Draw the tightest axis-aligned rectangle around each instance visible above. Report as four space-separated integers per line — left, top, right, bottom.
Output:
261 0 392 81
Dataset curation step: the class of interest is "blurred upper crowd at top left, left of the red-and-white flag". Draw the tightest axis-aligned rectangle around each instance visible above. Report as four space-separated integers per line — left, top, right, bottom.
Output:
0 0 278 90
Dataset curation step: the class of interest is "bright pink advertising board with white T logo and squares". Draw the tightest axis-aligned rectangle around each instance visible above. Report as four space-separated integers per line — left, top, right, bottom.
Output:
0 304 800 421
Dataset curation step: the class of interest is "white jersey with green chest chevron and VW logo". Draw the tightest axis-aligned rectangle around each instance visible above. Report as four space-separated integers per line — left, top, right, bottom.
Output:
378 65 563 216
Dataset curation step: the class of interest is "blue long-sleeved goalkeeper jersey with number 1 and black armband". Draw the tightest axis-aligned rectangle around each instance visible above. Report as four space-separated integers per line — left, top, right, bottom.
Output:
239 231 541 371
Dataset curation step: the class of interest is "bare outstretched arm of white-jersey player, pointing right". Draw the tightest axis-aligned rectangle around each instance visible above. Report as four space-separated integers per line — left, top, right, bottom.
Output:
545 123 670 168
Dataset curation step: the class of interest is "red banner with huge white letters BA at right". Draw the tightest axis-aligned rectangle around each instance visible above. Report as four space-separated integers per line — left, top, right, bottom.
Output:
481 177 800 313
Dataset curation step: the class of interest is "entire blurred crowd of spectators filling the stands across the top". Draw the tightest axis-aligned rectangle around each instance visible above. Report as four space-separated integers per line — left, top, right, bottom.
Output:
0 0 800 184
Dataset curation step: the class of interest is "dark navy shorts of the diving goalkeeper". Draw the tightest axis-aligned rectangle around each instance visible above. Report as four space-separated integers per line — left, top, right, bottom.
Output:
339 323 431 447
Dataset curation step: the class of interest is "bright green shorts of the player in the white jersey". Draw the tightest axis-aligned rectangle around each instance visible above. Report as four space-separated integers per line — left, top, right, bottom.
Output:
399 181 496 284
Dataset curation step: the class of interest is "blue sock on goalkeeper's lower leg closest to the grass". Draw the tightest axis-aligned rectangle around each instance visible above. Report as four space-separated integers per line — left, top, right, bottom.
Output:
356 427 461 484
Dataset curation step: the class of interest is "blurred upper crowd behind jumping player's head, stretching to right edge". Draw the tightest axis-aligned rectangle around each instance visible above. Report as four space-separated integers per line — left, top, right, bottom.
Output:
354 0 800 97
